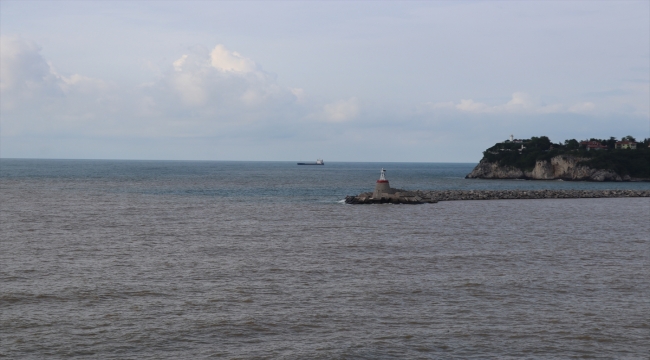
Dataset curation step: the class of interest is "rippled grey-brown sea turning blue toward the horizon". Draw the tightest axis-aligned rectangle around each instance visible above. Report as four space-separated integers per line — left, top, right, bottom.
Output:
0 159 650 359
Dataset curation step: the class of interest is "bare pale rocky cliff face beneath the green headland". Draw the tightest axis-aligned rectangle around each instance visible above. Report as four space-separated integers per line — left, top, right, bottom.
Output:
466 155 630 181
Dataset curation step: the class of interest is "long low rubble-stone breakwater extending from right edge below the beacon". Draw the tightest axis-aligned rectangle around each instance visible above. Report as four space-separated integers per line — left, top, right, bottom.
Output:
345 190 650 204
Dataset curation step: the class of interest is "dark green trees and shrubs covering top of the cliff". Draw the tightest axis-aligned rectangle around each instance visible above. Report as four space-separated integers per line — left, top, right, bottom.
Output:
483 136 650 178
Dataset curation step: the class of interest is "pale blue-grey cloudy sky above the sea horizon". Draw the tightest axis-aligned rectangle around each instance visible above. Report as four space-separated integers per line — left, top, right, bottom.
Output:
0 0 650 162
